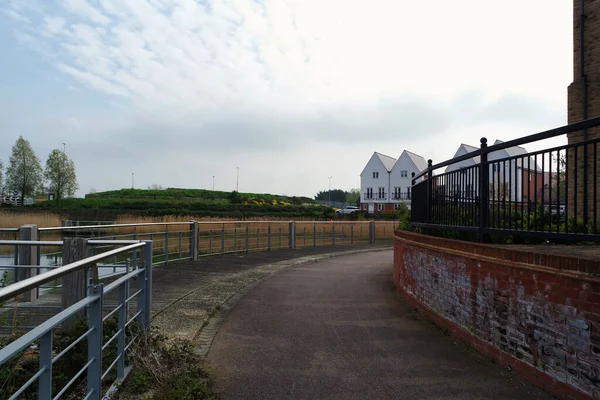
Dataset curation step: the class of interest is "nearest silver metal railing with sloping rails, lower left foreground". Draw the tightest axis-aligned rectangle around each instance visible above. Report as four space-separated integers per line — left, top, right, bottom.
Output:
0 241 152 400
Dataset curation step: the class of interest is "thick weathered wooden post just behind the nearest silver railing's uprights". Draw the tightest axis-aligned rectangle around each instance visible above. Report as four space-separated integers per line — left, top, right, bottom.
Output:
62 237 89 329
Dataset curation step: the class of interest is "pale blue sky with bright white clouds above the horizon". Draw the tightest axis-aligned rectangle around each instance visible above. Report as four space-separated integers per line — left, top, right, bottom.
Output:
0 0 573 196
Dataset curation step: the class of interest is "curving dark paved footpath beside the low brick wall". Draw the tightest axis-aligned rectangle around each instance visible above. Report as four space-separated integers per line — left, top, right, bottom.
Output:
208 251 552 400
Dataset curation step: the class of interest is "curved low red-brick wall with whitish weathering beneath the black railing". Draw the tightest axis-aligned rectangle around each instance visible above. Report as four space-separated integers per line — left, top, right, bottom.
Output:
394 231 600 399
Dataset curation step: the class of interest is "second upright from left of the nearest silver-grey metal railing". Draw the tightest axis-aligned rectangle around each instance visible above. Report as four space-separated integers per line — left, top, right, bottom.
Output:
87 284 104 399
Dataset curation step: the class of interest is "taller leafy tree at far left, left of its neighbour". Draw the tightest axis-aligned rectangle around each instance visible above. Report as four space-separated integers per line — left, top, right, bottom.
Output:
6 136 43 204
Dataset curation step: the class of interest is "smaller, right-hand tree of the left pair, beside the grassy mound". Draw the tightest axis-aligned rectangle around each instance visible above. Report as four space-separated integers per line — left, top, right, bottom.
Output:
44 149 79 205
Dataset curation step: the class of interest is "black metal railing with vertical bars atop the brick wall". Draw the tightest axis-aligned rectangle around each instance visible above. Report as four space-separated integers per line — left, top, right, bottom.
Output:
411 118 600 242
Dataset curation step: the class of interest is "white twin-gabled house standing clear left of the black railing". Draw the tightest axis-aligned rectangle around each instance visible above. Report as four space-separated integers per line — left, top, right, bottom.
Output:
360 150 427 214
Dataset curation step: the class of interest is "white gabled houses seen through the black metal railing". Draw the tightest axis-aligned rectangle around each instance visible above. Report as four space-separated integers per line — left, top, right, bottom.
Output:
437 140 549 202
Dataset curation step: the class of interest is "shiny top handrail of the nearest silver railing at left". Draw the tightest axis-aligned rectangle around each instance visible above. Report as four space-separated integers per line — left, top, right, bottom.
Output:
0 241 146 302
